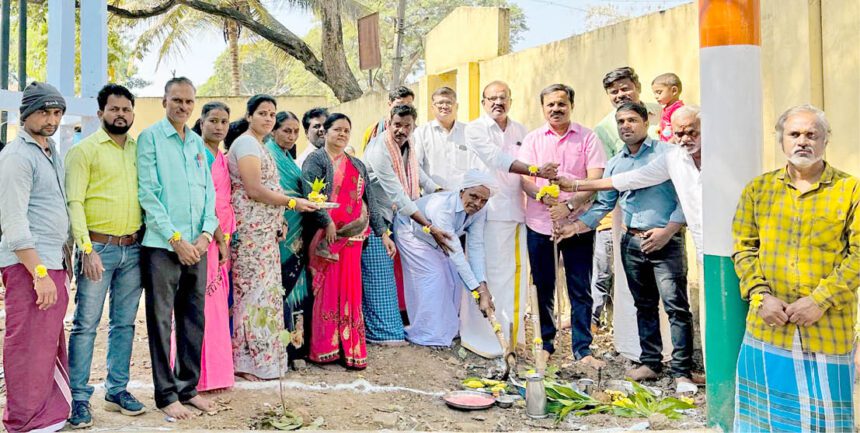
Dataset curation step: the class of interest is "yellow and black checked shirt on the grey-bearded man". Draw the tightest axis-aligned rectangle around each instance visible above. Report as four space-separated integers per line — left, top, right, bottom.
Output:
732 164 860 355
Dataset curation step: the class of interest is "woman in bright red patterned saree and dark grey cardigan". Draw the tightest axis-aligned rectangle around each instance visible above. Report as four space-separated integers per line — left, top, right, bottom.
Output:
302 113 395 369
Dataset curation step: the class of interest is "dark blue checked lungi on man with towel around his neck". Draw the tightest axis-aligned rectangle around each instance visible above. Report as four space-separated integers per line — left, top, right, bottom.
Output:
361 235 406 343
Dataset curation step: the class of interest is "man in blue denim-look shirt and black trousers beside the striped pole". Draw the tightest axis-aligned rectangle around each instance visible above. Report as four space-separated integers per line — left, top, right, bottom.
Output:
562 102 693 385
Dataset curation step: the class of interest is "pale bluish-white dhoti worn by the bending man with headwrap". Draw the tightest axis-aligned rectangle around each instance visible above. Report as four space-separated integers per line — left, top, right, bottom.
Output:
394 217 465 346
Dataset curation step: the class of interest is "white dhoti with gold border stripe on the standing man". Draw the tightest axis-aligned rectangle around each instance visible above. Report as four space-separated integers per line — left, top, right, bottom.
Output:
460 220 529 358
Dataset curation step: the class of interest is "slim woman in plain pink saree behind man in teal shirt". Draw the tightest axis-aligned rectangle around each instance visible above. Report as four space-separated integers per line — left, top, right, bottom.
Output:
195 102 236 391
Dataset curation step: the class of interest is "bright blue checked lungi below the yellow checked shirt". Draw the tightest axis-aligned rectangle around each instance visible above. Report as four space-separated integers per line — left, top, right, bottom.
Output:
734 334 855 433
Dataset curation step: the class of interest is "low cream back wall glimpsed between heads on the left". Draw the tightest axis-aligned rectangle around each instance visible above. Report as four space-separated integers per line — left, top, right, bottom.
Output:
130 96 327 152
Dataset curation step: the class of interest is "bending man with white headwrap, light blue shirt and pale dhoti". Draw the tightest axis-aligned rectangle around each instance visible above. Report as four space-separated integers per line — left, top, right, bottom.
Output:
394 170 495 347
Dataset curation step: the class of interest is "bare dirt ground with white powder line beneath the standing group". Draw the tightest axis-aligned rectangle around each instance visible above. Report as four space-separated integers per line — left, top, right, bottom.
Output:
0 284 705 431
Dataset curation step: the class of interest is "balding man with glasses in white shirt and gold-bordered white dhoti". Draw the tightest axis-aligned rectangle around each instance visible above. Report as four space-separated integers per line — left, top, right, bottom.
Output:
460 81 558 358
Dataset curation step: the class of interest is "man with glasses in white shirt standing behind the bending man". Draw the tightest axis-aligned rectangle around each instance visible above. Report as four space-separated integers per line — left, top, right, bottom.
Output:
412 87 477 194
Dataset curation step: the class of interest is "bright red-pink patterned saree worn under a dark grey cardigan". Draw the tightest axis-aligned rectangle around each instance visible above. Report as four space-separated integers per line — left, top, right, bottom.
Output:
309 156 367 369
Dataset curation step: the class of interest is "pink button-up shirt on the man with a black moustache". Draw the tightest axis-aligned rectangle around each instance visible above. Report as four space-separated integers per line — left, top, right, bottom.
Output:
519 122 606 235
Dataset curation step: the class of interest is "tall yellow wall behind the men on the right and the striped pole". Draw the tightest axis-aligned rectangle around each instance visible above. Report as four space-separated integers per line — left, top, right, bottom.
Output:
328 0 860 175
